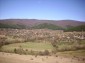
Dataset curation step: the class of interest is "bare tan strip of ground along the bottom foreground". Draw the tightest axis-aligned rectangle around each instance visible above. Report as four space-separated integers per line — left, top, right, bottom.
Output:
0 52 85 63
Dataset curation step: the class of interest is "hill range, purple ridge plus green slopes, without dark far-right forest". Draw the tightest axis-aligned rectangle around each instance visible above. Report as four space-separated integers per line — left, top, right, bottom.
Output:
0 19 85 30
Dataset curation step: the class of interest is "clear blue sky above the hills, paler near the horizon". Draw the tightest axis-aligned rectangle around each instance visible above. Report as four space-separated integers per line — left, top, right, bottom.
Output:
0 0 85 21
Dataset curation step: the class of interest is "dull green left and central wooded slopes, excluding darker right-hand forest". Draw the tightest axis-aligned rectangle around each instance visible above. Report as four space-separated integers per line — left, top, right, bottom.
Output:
0 23 63 30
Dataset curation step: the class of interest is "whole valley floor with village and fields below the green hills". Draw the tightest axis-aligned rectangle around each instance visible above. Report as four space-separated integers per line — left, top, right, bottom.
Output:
0 28 85 63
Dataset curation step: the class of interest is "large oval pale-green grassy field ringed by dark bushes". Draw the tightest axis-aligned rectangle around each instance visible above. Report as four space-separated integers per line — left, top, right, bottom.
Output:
1 42 53 52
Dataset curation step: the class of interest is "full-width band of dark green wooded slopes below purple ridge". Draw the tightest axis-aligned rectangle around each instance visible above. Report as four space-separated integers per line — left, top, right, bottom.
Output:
0 23 85 31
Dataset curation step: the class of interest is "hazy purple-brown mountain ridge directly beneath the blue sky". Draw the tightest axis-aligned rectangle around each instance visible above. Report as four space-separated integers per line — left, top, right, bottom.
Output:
0 19 85 28
